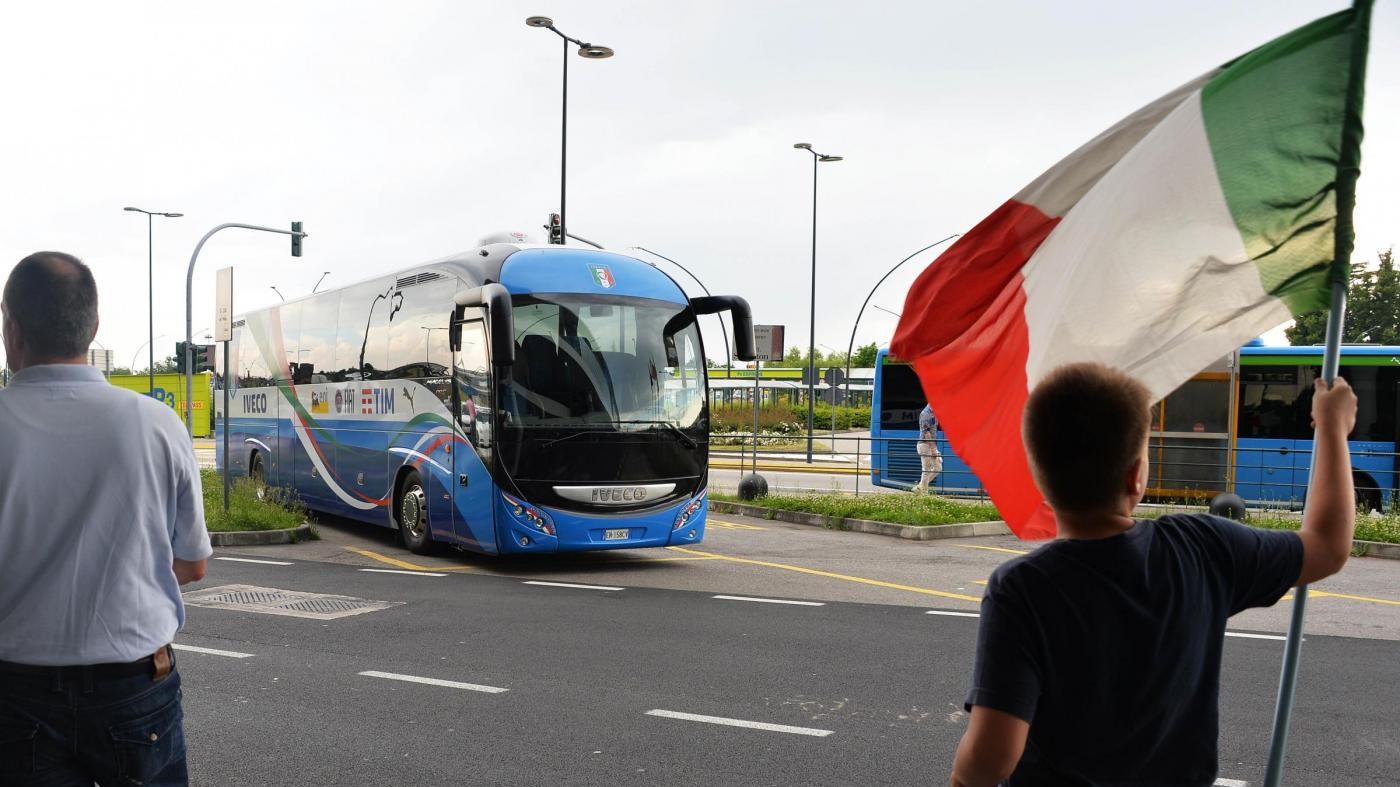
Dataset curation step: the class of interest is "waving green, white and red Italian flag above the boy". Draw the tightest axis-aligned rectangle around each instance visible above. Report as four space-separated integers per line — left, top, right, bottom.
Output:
890 1 1369 539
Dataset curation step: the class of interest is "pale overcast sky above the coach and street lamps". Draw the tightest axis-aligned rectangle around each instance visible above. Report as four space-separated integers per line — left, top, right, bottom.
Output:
0 0 1400 368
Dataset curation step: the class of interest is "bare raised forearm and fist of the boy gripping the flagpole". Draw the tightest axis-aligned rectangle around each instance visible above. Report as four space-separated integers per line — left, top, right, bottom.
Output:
1298 377 1357 585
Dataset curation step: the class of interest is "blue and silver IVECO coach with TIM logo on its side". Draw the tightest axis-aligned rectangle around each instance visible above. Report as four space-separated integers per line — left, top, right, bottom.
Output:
216 242 753 555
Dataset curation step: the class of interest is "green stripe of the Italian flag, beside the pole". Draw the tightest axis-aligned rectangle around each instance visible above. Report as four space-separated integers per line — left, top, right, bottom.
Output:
1201 10 1365 315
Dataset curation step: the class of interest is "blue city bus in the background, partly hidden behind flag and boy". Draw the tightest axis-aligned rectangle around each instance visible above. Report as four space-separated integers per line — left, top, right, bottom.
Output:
871 342 1400 511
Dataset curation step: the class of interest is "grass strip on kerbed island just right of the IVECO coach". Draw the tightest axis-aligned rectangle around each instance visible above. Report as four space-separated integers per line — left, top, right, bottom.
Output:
710 492 1001 525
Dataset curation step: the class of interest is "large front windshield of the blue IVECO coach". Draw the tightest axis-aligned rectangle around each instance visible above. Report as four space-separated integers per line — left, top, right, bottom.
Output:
501 294 704 431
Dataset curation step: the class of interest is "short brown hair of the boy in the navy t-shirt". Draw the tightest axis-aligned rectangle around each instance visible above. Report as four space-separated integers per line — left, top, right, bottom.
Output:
1021 363 1152 511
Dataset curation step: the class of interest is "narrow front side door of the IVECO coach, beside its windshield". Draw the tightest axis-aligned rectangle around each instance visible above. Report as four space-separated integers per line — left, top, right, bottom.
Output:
452 319 497 553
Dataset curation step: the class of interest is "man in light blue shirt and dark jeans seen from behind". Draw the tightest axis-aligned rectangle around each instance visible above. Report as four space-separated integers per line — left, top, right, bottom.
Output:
0 252 211 786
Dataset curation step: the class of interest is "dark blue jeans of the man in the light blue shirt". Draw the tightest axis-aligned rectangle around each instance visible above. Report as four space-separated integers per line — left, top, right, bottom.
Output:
0 665 189 787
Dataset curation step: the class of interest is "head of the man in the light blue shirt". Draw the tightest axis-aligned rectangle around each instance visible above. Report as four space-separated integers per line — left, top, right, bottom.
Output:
4 252 97 360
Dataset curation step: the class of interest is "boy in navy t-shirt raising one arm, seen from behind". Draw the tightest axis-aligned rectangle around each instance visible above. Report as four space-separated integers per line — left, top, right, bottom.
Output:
952 364 1357 787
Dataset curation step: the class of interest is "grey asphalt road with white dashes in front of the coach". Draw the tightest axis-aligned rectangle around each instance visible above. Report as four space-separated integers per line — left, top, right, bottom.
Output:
178 517 1400 786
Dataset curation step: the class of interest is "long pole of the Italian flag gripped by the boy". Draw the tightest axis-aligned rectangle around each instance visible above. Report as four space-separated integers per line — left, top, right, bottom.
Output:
1264 0 1372 787
